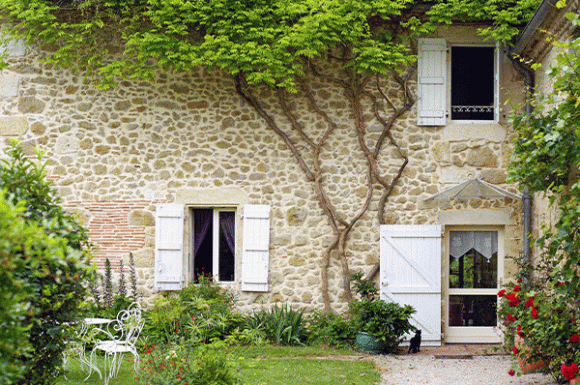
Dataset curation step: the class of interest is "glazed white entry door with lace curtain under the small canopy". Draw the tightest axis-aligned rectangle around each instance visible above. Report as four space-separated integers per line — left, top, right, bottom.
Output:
445 227 504 343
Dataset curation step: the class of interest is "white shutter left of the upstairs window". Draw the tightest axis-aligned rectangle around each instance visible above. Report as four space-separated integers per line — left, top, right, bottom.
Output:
417 39 447 126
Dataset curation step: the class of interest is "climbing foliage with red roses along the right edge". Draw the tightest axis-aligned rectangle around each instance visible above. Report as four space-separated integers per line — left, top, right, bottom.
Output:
509 14 580 380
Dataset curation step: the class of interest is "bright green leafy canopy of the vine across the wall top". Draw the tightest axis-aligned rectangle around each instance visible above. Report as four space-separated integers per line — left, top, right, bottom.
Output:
0 0 539 88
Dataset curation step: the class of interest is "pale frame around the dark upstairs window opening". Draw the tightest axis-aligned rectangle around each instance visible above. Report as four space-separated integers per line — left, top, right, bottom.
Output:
446 41 500 124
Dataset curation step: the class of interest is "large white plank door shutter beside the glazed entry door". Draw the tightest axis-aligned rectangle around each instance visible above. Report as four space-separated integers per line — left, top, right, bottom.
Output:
380 225 441 346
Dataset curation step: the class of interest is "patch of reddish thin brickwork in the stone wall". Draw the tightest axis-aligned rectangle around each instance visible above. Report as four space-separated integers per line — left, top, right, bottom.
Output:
63 200 164 271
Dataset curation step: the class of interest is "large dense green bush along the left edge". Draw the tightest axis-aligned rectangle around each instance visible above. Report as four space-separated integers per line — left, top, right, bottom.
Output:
0 145 92 384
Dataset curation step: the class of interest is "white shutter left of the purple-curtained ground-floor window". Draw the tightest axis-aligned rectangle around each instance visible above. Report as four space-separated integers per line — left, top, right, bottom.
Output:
155 203 184 290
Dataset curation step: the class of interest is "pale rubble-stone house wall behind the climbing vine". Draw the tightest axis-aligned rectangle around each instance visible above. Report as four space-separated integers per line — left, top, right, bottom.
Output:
0 21 523 342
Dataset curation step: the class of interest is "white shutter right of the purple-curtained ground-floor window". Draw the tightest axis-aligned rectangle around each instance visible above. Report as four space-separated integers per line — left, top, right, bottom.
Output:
242 205 270 291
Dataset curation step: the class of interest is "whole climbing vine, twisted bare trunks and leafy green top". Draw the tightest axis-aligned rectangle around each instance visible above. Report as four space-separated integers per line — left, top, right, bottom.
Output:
0 0 539 311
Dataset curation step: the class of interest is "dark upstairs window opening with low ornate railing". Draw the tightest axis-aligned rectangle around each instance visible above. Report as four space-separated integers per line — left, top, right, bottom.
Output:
451 47 495 120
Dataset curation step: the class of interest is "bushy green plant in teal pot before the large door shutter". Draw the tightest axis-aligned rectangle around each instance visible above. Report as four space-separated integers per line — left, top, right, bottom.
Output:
350 272 416 354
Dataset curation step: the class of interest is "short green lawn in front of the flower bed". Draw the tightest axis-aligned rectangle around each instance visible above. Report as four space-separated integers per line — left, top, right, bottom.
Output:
57 346 380 385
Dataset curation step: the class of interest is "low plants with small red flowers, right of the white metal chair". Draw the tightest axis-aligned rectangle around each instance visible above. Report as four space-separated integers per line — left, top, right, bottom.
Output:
137 342 242 385
